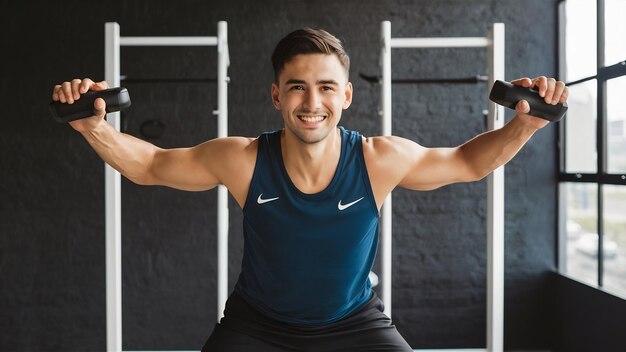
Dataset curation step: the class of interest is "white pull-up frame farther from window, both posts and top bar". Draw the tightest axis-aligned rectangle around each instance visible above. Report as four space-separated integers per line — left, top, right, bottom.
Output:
104 21 230 352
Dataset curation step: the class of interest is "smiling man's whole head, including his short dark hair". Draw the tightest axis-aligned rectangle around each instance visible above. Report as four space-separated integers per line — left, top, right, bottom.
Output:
272 29 352 144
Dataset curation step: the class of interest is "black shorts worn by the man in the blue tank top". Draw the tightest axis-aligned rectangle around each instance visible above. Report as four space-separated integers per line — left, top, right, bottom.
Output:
202 293 413 352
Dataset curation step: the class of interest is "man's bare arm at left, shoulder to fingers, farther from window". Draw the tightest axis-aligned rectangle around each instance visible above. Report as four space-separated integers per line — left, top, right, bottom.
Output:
52 79 254 201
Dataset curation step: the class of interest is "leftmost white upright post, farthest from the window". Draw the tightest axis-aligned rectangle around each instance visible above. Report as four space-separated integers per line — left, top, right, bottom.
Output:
104 22 122 352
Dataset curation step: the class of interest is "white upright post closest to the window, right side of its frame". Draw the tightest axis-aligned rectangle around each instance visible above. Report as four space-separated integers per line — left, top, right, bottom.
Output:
486 23 504 352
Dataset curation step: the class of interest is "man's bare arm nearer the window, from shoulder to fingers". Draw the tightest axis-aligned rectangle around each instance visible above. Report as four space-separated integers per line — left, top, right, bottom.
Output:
364 77 568 205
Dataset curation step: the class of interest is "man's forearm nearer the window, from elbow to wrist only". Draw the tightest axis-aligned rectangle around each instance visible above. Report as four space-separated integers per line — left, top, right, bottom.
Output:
460 116 537 179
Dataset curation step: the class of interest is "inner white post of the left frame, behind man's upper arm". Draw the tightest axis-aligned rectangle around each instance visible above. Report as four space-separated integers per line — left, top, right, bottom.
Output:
217 21 230 322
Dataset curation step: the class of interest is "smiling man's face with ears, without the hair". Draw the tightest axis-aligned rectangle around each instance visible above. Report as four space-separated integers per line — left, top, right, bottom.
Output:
272 54 352 144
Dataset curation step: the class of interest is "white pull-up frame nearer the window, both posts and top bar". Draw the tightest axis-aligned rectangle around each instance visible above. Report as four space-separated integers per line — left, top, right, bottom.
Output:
380 21 504 352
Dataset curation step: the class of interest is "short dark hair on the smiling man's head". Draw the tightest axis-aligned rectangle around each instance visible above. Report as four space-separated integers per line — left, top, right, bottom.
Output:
272 28 350 84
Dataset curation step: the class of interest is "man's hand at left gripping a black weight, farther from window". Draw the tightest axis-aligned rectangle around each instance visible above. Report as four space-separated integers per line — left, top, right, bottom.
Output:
52 78 109 132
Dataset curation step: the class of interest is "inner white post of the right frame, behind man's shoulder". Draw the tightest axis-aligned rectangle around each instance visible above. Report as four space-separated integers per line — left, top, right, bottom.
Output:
380 21 392 318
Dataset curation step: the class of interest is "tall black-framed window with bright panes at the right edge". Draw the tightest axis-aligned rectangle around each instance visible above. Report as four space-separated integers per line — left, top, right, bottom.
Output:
559 0 626 297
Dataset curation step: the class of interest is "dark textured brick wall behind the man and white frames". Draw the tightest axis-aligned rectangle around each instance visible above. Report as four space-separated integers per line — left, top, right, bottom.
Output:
0 0 557 351
